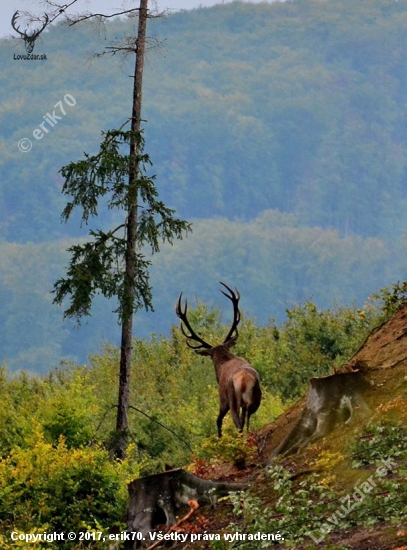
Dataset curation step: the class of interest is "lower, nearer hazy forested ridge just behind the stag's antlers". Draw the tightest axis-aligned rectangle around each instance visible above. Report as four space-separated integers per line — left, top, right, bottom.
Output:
0 211 407 372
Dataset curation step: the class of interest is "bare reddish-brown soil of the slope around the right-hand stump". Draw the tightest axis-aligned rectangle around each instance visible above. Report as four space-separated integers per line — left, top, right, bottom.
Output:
185 304 407 550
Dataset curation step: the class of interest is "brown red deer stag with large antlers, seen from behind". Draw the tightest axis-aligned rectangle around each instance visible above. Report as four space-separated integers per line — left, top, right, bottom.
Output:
175 282 261 437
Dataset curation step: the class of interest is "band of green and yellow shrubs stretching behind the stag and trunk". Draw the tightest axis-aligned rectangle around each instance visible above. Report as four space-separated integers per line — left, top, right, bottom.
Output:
0 303 400 550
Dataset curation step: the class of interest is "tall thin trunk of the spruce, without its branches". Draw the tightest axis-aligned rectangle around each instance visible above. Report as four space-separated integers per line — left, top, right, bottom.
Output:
115 0 148 460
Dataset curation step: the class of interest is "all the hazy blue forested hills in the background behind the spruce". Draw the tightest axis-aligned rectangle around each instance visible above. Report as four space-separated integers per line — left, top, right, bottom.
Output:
0 0 407 372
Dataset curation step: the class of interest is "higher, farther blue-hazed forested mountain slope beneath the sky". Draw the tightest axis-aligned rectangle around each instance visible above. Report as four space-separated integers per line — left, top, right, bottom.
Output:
0 0 407 242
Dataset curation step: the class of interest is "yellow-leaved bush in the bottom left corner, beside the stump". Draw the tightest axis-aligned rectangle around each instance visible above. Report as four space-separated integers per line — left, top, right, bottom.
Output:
0 426 138 548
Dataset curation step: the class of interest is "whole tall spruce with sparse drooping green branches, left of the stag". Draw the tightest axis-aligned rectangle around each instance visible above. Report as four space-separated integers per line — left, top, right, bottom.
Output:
50 0 190 459
